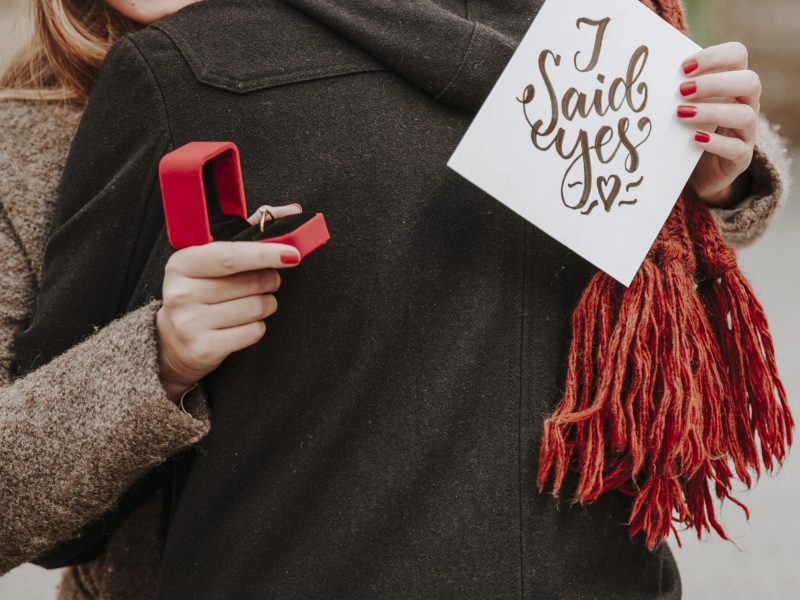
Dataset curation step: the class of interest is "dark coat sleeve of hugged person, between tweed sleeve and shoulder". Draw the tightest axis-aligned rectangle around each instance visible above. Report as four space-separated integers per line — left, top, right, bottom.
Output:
15 38 172 374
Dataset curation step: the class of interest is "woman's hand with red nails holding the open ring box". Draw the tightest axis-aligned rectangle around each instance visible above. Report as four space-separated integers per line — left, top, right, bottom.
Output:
156 204 302 402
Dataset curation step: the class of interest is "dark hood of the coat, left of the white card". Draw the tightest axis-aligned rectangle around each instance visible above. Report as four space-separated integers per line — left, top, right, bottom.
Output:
281 0 544 111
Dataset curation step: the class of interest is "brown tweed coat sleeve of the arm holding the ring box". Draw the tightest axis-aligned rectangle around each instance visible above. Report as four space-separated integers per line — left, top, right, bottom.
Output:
0 202 209 574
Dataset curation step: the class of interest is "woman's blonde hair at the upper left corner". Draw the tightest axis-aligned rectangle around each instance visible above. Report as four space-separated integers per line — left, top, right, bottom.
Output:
0 0 138 105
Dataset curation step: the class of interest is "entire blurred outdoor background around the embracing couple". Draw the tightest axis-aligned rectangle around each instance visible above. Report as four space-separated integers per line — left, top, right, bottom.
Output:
0 0 800 600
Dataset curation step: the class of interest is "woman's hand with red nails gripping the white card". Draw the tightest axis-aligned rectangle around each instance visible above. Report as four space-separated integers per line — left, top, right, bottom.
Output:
678 42 761 205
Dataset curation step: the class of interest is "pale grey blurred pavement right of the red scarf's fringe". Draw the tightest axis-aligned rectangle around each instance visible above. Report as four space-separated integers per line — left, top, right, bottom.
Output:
672 156 800 600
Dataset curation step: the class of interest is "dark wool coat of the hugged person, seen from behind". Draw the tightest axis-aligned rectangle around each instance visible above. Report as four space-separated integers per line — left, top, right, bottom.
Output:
3 0 792 598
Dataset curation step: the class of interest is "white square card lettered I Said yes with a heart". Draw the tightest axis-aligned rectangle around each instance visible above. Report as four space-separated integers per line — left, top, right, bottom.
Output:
447 0 707 286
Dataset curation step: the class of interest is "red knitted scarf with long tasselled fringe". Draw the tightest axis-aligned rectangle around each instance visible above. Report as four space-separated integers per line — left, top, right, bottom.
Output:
538 0 794 550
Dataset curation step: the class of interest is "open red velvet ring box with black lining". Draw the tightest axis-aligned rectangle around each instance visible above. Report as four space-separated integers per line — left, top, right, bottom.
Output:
158 142 330 257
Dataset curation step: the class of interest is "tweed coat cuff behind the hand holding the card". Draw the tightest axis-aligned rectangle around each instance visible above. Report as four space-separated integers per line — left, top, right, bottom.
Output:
711 116 791 246
